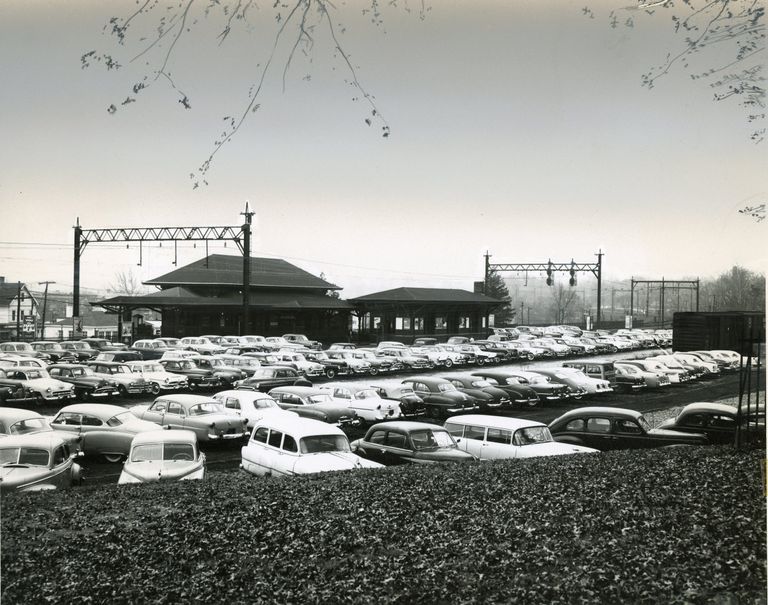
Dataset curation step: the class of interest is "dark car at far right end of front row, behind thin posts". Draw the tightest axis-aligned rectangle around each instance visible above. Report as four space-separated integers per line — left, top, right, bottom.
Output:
659 402 765 443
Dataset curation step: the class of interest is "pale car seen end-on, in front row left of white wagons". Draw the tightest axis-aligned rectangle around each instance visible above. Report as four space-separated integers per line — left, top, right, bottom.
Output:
117 429 205 485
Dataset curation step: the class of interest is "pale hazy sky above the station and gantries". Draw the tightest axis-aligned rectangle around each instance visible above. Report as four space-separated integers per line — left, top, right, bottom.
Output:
0 0 768 298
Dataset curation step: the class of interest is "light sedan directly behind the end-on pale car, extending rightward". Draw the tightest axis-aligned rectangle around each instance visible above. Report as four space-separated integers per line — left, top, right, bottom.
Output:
131 394 248 442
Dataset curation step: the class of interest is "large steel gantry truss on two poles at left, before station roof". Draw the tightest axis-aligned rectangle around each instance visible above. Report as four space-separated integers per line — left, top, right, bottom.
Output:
72 202 254 334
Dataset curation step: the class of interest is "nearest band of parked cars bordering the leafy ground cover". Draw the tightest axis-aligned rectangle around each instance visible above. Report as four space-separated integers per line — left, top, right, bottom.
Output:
0 391 765 493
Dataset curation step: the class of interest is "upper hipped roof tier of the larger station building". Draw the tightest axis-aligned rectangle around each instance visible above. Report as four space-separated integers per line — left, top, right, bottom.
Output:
144 254 341 290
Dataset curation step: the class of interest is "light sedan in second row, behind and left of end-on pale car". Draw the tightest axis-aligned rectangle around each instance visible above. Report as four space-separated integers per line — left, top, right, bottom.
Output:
51 403 157 462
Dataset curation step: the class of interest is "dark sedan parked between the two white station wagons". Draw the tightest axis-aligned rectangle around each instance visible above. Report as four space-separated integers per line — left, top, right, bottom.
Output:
350 420 476 465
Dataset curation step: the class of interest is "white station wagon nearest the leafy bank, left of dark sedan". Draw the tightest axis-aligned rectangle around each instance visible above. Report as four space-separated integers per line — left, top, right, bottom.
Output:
240 416 382 476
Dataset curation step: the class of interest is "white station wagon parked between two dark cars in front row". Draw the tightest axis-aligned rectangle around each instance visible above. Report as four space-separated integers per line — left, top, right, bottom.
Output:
444 414 598 460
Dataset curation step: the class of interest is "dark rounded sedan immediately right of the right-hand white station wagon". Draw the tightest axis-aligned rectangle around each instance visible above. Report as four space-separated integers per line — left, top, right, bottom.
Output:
549 407 708 451
